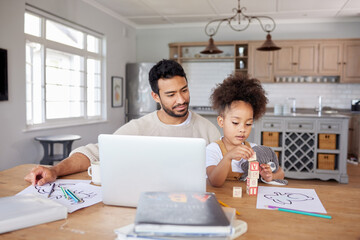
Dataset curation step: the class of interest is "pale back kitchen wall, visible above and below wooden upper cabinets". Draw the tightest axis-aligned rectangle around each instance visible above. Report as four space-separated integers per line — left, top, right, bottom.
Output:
137 21 360 109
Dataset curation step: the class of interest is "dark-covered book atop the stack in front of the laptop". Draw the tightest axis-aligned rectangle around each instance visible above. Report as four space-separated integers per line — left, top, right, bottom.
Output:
134 192 232 237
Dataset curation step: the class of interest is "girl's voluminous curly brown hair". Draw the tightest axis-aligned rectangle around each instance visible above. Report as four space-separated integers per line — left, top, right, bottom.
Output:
210 73 268 120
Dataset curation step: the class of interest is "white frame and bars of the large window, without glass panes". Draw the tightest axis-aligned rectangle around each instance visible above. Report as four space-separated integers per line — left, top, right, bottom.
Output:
24 5 106 130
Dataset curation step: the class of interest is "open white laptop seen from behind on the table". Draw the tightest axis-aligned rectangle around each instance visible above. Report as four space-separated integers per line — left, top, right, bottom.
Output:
99 134 206 207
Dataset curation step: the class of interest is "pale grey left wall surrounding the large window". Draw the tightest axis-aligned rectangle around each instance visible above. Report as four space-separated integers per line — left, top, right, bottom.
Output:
0 0 136 170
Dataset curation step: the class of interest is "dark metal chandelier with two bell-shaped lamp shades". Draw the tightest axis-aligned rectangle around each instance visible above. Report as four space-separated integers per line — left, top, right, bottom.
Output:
200 0 281 54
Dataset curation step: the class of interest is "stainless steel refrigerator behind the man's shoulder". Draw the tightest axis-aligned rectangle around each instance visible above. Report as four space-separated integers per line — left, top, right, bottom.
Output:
125 63 159 122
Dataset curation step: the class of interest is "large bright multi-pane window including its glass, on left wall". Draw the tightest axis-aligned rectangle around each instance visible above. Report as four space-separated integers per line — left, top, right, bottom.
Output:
24 9 105 127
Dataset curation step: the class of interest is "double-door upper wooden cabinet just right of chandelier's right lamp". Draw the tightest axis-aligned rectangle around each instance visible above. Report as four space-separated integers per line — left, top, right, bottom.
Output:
274 41 318 75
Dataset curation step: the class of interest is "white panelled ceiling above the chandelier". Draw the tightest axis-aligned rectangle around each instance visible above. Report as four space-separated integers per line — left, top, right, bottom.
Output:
83 0 360 28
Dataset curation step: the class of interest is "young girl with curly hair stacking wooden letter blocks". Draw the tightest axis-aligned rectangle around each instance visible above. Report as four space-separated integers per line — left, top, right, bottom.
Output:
206 74 284 187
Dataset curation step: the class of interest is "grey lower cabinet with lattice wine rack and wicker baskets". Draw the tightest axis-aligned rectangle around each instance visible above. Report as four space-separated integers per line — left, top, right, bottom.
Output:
254 114 349 183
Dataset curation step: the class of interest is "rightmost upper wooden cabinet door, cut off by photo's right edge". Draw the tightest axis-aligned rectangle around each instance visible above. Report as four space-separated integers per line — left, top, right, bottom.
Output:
341 40 360 83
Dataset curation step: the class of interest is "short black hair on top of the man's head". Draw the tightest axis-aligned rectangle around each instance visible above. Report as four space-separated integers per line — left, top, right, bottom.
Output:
149 59 187 94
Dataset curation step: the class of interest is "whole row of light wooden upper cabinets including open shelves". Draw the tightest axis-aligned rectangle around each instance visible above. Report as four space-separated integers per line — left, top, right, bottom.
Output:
169 39 360 83
